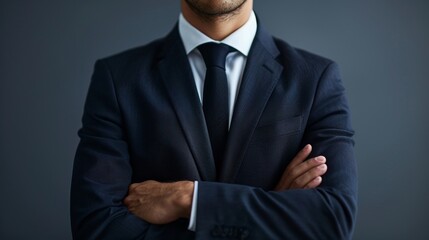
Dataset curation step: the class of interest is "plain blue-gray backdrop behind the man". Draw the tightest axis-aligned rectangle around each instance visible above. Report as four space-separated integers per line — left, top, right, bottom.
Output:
0 0 429 239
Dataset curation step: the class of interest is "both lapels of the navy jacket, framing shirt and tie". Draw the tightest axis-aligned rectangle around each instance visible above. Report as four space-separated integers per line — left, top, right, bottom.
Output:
158 25 283 182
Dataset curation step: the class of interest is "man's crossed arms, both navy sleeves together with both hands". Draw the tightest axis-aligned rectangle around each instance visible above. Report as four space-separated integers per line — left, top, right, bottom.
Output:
71 59 356 239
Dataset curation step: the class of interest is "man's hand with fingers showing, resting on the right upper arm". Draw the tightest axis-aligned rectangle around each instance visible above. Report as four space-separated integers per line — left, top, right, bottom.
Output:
274 144 328 191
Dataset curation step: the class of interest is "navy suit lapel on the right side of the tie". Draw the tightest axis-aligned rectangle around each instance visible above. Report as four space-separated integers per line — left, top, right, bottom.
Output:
219 27 283 182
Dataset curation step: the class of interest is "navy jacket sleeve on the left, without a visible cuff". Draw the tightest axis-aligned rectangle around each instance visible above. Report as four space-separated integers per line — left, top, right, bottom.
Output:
71 61 148 239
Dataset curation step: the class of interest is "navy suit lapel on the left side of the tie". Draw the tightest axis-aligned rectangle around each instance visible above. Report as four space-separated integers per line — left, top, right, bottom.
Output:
158 27 216 181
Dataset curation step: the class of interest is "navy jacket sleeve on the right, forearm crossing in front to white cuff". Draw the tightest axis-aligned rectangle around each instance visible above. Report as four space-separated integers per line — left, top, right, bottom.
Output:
196 63 357 239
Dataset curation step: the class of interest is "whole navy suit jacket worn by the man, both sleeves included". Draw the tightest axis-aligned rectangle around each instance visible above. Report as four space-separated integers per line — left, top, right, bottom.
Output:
71 23 357 239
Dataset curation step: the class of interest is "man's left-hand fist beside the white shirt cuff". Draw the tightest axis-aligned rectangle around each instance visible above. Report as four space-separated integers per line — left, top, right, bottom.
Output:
124 180 194 224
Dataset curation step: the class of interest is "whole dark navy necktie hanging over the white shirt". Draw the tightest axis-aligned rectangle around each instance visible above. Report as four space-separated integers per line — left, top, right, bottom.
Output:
198 42 233 176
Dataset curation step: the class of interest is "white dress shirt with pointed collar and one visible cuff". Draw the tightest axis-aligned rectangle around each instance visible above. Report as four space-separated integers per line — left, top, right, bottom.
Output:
179 12 257 231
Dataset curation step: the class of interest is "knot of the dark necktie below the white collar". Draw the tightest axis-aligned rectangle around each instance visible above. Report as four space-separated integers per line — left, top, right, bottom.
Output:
198 42 234 69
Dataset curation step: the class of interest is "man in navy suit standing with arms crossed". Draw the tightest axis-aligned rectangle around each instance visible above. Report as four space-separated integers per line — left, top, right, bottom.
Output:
71 0 357 239
